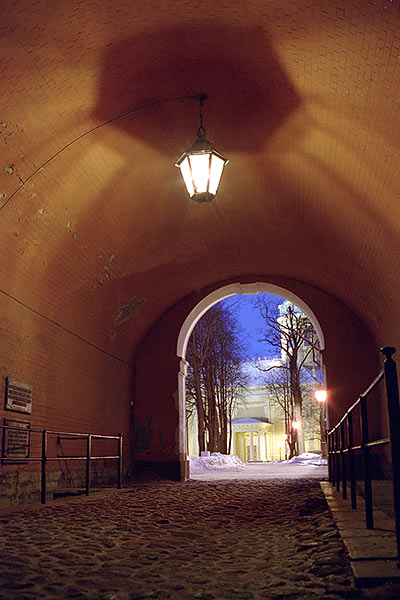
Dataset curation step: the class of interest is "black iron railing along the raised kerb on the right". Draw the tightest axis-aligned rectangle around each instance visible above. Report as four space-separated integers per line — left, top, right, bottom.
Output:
328 347 400 567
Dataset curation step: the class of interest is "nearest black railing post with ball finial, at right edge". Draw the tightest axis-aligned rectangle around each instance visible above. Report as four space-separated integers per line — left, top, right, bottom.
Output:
381 347 400 567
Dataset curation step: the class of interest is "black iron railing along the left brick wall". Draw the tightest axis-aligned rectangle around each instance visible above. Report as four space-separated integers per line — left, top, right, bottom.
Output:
0 425 122 504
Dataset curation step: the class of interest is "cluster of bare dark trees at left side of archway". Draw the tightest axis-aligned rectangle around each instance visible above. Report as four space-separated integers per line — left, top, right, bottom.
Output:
186 303 245 454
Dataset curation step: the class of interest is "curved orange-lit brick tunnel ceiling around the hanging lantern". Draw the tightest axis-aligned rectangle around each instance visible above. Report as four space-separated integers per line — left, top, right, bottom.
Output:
0 0 400 360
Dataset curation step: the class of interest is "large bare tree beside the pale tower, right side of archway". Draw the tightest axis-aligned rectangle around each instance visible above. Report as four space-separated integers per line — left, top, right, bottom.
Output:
254 295 320 454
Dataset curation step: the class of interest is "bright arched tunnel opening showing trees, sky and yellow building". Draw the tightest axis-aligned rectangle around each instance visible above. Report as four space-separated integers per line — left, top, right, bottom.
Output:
180 284 327 480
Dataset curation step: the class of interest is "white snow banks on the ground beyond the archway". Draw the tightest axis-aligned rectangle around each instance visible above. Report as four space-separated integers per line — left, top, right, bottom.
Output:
188 452 327 473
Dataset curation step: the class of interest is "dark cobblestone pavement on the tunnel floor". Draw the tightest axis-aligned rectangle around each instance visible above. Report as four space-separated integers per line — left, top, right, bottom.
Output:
0 478 368 600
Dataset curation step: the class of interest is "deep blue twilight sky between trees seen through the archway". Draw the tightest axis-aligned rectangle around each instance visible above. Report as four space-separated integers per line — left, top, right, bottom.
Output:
221 294 285 360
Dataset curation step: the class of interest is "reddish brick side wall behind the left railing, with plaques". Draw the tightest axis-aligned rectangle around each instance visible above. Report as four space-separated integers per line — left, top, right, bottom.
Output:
0 296 132 505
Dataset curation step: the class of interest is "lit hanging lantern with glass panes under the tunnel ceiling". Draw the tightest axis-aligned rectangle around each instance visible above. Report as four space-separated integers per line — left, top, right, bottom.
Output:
175 94 229 202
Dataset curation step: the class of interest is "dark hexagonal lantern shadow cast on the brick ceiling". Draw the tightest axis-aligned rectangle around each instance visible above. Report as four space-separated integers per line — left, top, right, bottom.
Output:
94 25 301 157
